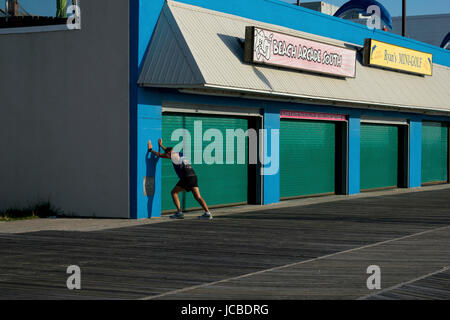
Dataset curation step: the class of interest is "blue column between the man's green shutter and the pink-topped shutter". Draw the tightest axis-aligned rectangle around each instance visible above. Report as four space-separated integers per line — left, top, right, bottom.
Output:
263 107 280 204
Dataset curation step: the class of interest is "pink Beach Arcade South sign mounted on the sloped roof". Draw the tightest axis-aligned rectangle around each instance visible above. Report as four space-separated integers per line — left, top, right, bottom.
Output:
245 27 356 78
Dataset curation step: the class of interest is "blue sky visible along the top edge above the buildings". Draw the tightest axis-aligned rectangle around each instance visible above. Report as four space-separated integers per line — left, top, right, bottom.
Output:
0 0 450 17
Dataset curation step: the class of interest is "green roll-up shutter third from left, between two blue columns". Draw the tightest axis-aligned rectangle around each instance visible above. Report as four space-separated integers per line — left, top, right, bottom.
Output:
360 124 399 190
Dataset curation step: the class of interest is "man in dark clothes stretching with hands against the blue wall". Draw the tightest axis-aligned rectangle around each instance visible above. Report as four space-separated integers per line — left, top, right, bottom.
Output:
148 139 212 220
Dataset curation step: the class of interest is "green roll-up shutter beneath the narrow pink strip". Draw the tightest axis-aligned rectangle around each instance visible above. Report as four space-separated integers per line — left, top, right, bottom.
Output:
280 120 336 198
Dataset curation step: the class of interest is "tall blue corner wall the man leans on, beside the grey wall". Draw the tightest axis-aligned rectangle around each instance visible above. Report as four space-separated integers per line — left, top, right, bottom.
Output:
129 0 164 219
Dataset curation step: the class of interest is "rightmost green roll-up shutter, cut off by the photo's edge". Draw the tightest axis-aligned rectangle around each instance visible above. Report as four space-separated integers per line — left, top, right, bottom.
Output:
422 122 448 183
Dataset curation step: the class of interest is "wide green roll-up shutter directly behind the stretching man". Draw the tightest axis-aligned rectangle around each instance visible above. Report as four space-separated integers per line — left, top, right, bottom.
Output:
162 114 248 211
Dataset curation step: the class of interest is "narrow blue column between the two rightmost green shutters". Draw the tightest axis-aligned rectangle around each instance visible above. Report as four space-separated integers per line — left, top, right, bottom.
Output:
409 120 422 188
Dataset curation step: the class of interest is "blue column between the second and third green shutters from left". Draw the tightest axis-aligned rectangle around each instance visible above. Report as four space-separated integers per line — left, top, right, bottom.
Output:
348 115 361 195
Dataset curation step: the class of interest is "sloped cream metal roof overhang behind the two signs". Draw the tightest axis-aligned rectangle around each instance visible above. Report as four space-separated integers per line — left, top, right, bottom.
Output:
138 1 450 115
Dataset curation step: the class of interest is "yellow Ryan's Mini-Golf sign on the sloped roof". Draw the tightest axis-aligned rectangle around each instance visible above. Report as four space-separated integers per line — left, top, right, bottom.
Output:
364 39 433 76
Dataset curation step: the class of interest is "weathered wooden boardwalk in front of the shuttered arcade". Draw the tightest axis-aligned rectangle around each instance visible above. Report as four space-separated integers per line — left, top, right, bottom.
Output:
0 189 450 299
